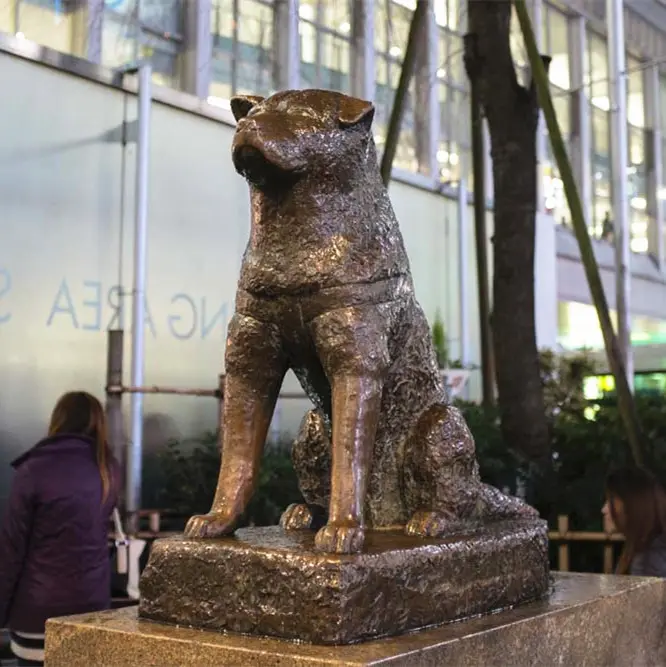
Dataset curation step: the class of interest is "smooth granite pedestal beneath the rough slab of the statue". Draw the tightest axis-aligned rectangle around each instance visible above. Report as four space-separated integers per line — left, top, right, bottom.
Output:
46 574 666 667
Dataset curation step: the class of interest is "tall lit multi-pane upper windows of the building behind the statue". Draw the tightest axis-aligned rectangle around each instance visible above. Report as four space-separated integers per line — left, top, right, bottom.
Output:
0 0 666 256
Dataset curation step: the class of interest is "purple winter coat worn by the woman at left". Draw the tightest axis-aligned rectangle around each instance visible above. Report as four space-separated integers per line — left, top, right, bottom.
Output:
0 435 119 633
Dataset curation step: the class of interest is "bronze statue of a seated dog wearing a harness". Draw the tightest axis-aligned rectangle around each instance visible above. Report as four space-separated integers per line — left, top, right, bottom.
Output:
185 90 536 553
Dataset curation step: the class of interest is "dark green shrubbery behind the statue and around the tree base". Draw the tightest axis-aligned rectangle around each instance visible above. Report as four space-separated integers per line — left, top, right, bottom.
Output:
144 352 666 569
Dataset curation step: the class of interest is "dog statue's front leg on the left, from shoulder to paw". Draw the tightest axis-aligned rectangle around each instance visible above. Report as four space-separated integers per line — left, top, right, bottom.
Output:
185 314 286 538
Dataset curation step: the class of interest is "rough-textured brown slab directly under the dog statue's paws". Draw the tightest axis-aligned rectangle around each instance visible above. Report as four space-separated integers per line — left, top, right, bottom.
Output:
139 520 549 644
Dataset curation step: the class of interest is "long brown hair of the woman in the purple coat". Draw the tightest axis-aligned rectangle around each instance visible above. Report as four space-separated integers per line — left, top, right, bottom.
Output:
49 391 112 502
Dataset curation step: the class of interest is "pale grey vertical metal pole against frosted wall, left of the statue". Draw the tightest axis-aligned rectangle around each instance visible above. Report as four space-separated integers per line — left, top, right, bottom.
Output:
125 63 152 534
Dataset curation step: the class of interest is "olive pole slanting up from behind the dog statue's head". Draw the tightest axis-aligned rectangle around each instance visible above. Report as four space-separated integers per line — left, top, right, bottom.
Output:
380 0 428 187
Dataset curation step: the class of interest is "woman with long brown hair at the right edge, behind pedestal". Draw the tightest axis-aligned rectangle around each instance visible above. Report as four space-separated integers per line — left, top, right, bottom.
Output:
602 467 666 577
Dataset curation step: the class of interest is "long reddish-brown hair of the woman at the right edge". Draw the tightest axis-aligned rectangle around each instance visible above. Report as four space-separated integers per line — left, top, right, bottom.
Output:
606 466 666 574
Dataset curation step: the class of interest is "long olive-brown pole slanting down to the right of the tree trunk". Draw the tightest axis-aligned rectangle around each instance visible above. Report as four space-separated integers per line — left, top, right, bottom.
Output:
514 0 643 465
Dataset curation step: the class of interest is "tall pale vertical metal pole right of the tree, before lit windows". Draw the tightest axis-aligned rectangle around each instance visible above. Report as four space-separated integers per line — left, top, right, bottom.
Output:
606 0 634 390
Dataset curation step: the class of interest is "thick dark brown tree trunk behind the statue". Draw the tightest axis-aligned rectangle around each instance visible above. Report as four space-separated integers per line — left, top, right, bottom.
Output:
465 0 550 466
